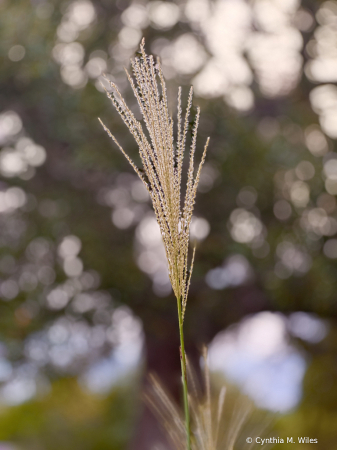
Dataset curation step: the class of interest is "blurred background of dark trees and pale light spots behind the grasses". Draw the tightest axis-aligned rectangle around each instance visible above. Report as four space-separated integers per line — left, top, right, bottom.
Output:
0 0 337 450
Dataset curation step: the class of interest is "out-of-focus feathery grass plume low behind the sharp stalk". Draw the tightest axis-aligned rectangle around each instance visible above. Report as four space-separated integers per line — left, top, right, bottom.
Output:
144 350 273 450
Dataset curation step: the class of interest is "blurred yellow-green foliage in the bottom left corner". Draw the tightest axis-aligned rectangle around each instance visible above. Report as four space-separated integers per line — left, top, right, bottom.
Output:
0 378 134 450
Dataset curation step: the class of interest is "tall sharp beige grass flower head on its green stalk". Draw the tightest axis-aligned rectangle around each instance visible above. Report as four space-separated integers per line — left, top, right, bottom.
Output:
99 39 209 450
